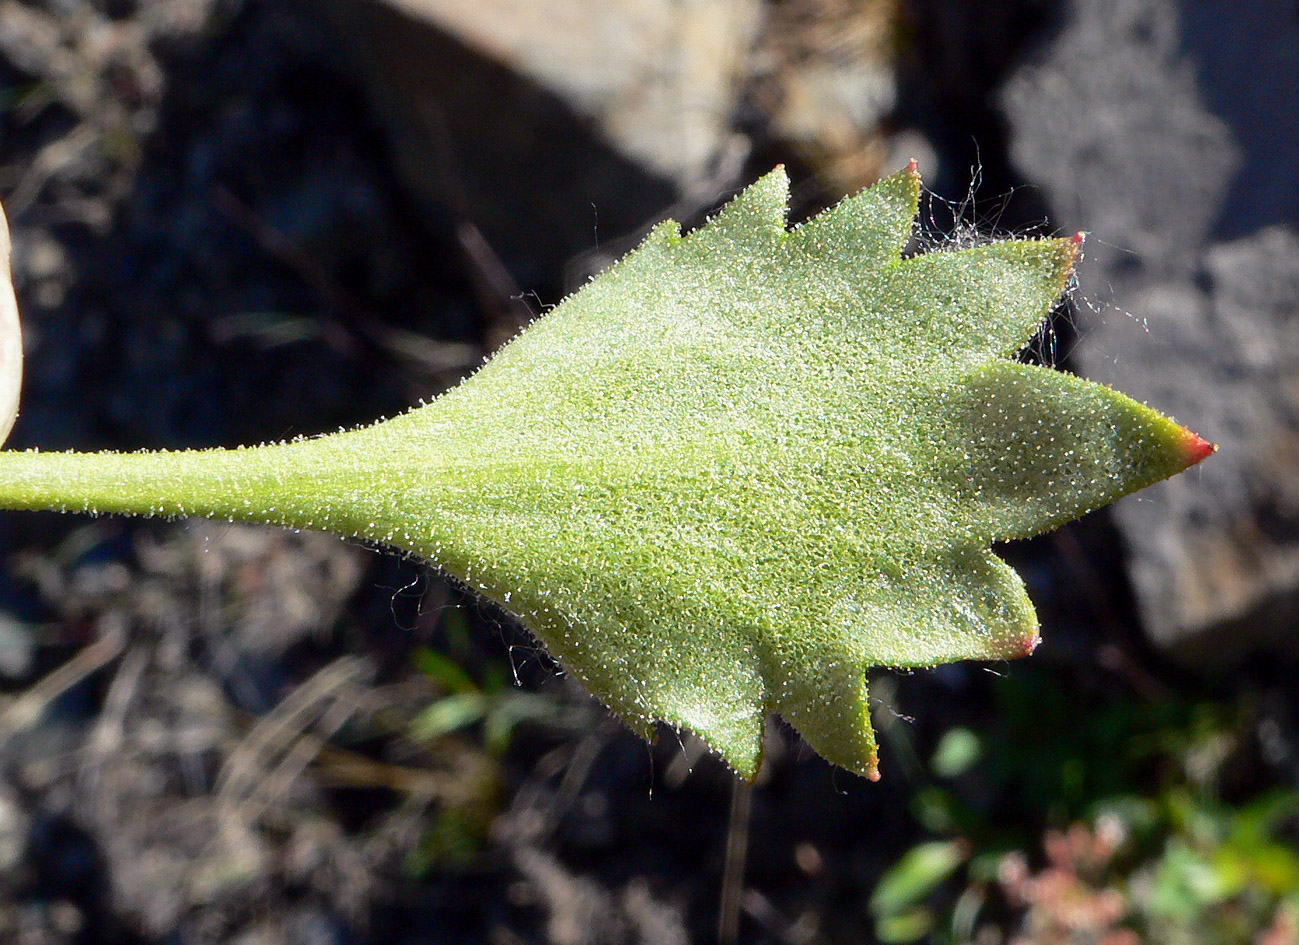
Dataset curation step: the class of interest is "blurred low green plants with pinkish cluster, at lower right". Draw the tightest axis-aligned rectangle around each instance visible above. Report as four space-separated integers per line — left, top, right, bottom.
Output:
870 667 1299 945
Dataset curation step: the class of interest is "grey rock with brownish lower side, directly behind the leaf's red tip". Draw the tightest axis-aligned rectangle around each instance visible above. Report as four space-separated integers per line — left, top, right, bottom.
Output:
1081 227 1299 669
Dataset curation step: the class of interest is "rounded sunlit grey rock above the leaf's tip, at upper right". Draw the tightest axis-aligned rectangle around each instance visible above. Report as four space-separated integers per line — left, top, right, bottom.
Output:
1005 0 1239 280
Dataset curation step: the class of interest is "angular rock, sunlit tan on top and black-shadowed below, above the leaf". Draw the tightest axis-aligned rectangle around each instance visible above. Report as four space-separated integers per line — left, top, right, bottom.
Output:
313 0 760 285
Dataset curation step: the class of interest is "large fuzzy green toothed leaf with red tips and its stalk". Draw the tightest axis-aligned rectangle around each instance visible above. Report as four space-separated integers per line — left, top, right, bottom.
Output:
0 168 1212 777
